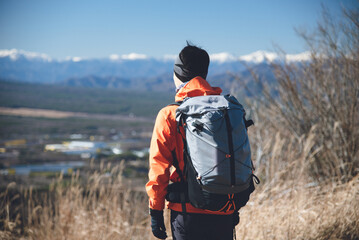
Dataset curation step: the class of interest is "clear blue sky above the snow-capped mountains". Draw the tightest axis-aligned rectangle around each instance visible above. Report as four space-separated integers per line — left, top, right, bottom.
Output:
0 0 359 59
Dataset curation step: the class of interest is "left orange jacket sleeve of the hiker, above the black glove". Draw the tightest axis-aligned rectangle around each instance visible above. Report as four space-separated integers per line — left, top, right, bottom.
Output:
146 108 175 210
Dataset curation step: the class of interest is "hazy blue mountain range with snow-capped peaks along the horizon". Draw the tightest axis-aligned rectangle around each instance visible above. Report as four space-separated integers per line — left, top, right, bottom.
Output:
0 49 310 91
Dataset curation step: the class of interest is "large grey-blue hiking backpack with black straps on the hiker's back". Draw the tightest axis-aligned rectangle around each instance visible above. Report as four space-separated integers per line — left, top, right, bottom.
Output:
167 95 259 212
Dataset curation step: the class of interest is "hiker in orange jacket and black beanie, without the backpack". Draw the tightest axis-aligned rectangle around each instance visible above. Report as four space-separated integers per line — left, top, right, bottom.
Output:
146 44 239 240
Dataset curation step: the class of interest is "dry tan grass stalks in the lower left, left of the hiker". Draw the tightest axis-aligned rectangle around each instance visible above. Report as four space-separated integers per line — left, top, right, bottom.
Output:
0 160 150 240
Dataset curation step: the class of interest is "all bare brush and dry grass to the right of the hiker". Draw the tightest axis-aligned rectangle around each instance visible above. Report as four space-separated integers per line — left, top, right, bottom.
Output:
237 6 359 239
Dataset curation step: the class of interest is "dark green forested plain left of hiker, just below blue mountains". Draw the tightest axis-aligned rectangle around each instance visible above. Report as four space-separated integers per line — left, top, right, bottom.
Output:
0 81 174 117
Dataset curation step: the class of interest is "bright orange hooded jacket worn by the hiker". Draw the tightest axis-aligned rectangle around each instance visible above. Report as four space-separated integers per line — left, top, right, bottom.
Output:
146 77 233 214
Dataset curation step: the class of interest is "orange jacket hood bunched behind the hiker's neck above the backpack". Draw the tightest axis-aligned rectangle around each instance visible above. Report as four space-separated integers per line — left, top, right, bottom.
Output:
175 77 222 102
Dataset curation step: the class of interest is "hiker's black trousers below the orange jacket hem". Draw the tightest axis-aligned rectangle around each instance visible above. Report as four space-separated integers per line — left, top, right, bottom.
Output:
171 210 233 240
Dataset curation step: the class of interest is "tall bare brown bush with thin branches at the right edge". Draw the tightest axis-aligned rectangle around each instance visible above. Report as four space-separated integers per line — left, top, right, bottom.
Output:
246 6 359 182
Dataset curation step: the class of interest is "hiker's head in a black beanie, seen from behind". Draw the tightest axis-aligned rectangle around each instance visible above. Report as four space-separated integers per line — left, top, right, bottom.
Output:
174 42 209 82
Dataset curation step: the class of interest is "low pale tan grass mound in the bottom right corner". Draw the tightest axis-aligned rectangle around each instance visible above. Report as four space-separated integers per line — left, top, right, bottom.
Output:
237 177 359 240
